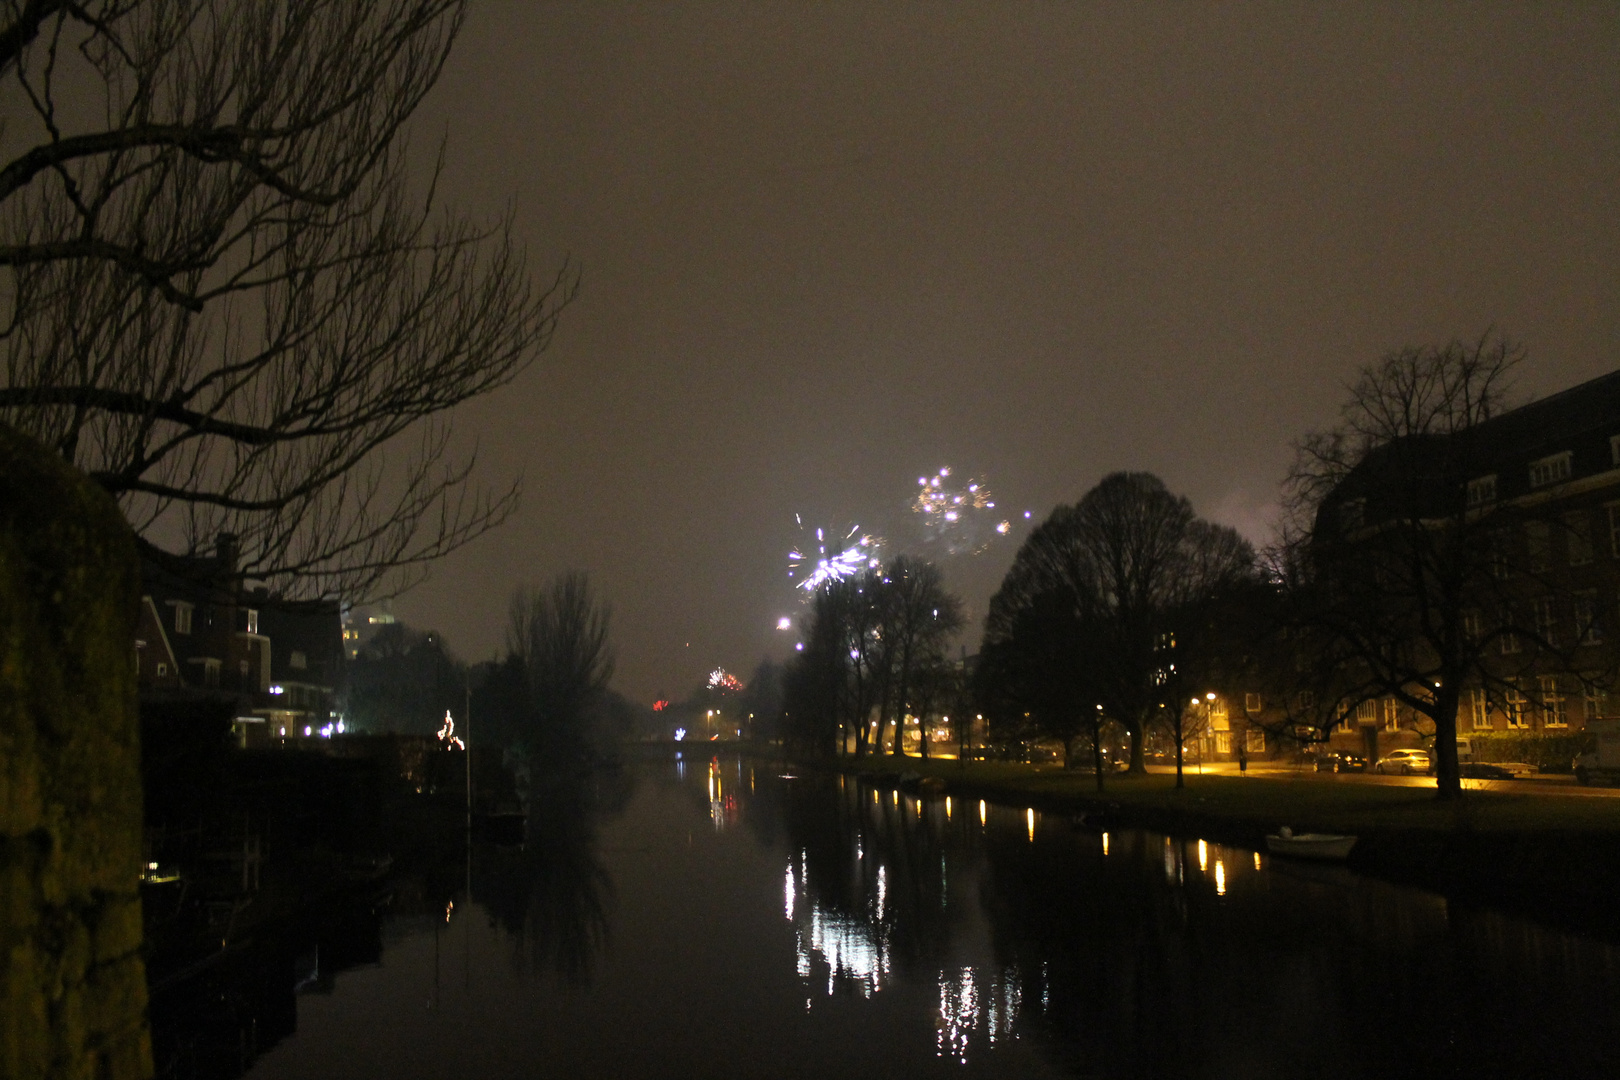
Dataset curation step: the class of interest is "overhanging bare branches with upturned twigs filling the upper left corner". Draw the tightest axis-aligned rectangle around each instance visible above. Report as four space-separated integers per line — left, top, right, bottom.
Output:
0 0 577 601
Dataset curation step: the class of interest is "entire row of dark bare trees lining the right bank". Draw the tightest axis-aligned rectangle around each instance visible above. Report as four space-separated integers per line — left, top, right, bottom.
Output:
787 335 1620 797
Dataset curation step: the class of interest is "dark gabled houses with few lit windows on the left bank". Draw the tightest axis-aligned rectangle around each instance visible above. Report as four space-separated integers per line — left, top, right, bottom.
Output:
134 533 343 745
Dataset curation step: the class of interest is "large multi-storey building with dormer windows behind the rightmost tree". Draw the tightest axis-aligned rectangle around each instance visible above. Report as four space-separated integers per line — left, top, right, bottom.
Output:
1199 371 1620 759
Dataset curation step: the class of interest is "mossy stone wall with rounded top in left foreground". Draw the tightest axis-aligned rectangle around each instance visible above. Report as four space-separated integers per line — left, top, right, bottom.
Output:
0 426 151 1080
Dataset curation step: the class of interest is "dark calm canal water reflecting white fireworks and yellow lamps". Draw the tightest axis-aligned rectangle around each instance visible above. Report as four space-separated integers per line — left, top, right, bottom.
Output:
196 753 1620 1080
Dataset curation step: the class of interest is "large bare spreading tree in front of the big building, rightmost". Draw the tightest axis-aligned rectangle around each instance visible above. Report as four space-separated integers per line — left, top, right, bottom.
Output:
1277 334 1612 798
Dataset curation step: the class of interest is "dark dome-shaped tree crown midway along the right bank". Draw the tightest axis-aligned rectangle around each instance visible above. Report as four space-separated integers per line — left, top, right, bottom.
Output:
974 473 1259 785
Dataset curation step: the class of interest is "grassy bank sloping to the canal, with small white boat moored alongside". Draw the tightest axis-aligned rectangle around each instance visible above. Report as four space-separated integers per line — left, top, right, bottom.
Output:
767 758 1620 939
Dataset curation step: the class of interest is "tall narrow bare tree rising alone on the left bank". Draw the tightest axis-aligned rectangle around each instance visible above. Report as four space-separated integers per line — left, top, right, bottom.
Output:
507 572 614 756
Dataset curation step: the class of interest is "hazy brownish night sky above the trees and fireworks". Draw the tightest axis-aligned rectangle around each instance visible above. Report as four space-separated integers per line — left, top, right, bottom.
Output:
394 0 1620 699
